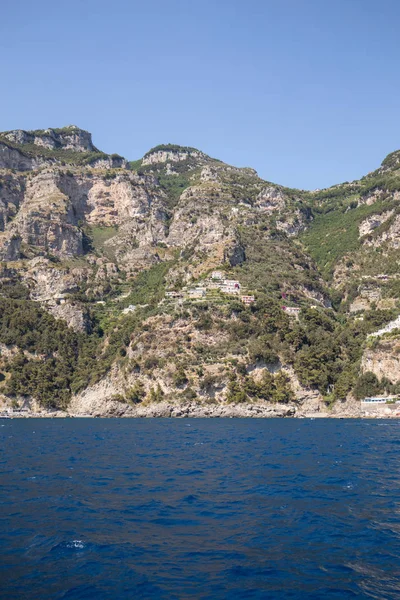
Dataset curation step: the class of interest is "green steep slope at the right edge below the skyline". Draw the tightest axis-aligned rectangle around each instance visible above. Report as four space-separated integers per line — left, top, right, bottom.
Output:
301 152 400 311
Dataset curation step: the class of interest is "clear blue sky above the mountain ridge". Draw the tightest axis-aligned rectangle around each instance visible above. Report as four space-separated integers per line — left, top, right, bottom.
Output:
0 0 400 189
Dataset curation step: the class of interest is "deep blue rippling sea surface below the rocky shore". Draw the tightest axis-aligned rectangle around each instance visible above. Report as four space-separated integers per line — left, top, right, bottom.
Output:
0 419 400 600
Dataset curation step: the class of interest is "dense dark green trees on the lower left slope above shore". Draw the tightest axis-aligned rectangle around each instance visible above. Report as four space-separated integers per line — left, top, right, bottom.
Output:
0 298 100 407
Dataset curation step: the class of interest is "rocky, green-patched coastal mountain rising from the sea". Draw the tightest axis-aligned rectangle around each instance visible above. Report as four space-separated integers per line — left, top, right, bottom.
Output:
0 125 400 415
